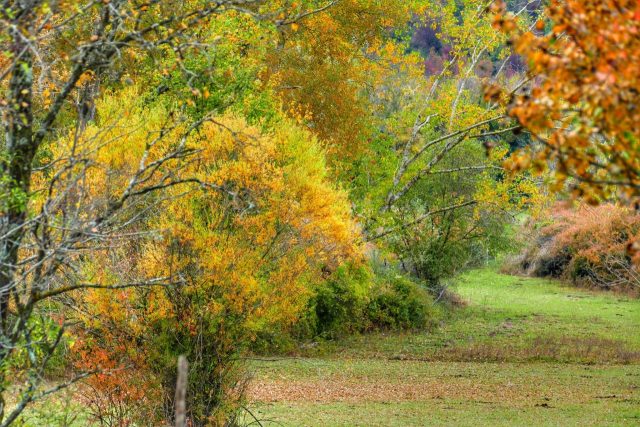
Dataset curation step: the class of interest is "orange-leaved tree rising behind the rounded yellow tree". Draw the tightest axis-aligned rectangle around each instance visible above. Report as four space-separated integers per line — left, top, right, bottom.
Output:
263 0 425 163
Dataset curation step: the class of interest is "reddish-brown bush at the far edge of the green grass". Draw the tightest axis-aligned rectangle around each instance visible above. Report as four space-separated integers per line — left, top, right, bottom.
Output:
506 204 640 293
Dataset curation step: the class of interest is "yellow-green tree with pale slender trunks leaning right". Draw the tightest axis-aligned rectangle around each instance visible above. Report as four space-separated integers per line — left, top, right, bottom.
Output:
361 0 541 290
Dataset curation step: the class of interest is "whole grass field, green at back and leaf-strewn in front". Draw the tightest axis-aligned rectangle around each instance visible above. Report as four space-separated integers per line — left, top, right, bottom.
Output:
245 269 640 426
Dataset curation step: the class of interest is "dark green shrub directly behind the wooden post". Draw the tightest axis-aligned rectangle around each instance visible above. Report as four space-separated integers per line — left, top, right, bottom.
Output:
150 307 248 427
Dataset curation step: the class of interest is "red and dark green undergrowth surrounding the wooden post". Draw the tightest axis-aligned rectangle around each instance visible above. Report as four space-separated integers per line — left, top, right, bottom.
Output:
74 287 249 427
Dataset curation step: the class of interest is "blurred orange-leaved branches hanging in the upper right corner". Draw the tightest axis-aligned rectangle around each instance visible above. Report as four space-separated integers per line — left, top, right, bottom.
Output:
488 0 640 203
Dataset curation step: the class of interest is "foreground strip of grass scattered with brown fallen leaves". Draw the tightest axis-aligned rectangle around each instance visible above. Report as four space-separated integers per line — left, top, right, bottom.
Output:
252 359 640 426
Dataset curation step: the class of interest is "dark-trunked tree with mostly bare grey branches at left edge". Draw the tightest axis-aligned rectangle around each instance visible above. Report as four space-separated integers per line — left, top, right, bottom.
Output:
0 0 340 426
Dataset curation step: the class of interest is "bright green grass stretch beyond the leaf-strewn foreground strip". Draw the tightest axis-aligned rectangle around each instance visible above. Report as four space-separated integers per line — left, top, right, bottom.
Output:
300 269 640 363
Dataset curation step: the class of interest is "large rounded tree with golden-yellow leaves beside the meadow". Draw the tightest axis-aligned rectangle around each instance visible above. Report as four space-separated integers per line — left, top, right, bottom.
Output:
49 88 361 423
